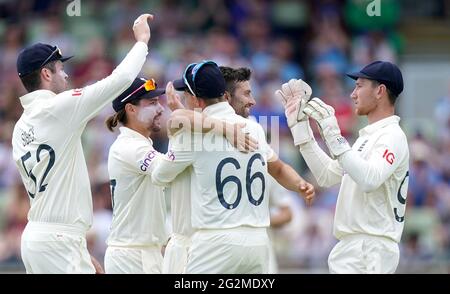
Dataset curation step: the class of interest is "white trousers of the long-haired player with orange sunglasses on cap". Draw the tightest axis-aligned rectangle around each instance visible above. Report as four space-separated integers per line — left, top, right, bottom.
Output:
105 245 163 274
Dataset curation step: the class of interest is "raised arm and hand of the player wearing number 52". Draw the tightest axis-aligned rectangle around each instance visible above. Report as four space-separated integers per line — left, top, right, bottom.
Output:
54 14 153 127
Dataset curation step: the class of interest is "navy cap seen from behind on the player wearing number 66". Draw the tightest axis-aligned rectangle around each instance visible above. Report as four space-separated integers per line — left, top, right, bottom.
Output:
173 61 225 99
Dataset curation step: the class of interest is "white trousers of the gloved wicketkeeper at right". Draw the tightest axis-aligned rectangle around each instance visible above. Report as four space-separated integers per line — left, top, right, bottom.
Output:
328 234 400 274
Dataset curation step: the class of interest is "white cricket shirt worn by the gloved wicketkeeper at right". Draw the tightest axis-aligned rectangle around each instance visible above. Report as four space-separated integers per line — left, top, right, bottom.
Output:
301 115 409 242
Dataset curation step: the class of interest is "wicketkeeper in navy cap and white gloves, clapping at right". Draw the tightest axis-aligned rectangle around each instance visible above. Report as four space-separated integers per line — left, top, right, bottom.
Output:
277 61 409 274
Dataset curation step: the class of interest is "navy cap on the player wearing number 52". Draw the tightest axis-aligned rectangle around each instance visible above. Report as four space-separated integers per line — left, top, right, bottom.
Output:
17 43 73 78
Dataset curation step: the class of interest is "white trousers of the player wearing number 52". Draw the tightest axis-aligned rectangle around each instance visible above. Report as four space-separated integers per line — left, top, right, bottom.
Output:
21 222 95 274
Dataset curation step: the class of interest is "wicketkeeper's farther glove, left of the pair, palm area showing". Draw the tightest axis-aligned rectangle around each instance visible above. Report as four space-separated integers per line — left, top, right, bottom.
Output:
275 79 312 128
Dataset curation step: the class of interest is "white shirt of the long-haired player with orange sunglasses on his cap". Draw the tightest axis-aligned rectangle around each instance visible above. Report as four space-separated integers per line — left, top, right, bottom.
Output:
107 127 167 246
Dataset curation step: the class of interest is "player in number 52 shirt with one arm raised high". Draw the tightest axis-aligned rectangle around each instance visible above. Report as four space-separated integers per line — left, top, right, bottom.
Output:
12 14 153 273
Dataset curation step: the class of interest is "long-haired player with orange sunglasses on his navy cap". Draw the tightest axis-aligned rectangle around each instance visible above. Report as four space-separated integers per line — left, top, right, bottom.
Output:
105 78 167 274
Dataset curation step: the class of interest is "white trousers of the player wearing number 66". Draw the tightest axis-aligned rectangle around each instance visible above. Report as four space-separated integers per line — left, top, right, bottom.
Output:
186 227 270 274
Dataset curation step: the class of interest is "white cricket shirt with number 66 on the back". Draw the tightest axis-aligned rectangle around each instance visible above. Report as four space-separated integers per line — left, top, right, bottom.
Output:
153 102 275 229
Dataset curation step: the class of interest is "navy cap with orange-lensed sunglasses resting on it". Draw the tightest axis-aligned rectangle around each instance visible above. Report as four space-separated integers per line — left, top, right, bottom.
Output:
113 78 166 112
